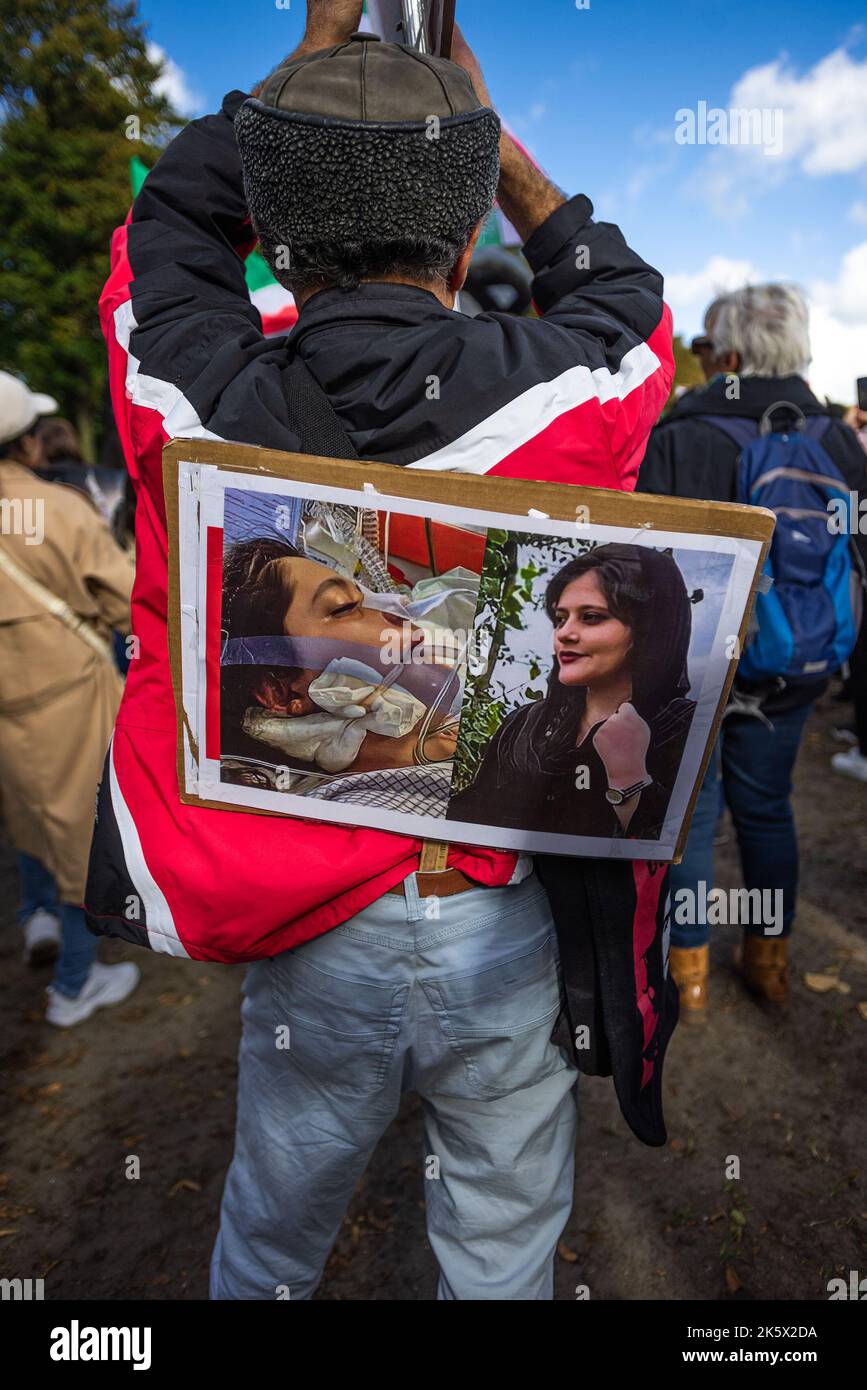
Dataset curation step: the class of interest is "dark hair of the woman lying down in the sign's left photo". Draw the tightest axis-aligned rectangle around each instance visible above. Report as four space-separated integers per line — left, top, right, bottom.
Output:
220 537 302 726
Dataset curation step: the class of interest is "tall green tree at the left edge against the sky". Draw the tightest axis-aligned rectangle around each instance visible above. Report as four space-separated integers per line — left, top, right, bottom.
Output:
0 0 179 457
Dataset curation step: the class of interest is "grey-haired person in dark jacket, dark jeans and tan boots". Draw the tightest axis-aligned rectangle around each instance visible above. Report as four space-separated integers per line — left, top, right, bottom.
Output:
638 284 867 1022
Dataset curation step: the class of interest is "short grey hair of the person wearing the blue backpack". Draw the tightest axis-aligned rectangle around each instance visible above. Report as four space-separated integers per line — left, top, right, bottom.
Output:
704 285 813 377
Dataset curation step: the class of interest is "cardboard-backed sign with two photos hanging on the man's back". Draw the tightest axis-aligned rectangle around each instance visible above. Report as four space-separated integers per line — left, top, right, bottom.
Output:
164 441 774 860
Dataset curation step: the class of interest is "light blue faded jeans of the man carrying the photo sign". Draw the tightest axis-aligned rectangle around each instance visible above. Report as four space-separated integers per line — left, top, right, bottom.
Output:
211 874 578 1300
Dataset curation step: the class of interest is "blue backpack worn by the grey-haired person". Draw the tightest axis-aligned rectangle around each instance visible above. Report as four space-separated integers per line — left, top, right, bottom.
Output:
699 400 860 681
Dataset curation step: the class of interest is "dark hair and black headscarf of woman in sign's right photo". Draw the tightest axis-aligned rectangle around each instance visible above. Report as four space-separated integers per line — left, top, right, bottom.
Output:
515 542 692 770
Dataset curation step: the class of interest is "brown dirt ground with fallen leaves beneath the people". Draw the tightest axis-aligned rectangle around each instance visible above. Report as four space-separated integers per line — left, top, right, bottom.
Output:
0 701 867 1300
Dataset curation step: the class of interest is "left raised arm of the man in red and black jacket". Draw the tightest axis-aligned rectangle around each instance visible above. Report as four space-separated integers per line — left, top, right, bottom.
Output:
100 0 361 512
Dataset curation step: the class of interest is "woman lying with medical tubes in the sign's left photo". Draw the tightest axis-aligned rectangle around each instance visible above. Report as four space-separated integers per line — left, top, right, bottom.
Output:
220 537 461 815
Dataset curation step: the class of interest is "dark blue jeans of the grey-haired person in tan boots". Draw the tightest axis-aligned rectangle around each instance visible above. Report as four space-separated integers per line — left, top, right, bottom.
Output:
670 705 813 947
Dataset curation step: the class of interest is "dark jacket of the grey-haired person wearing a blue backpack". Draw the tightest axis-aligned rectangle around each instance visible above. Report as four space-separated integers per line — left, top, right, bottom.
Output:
636 377 867 714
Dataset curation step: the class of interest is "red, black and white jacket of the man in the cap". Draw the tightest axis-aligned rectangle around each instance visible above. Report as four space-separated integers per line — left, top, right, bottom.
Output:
86 92 674 1141
